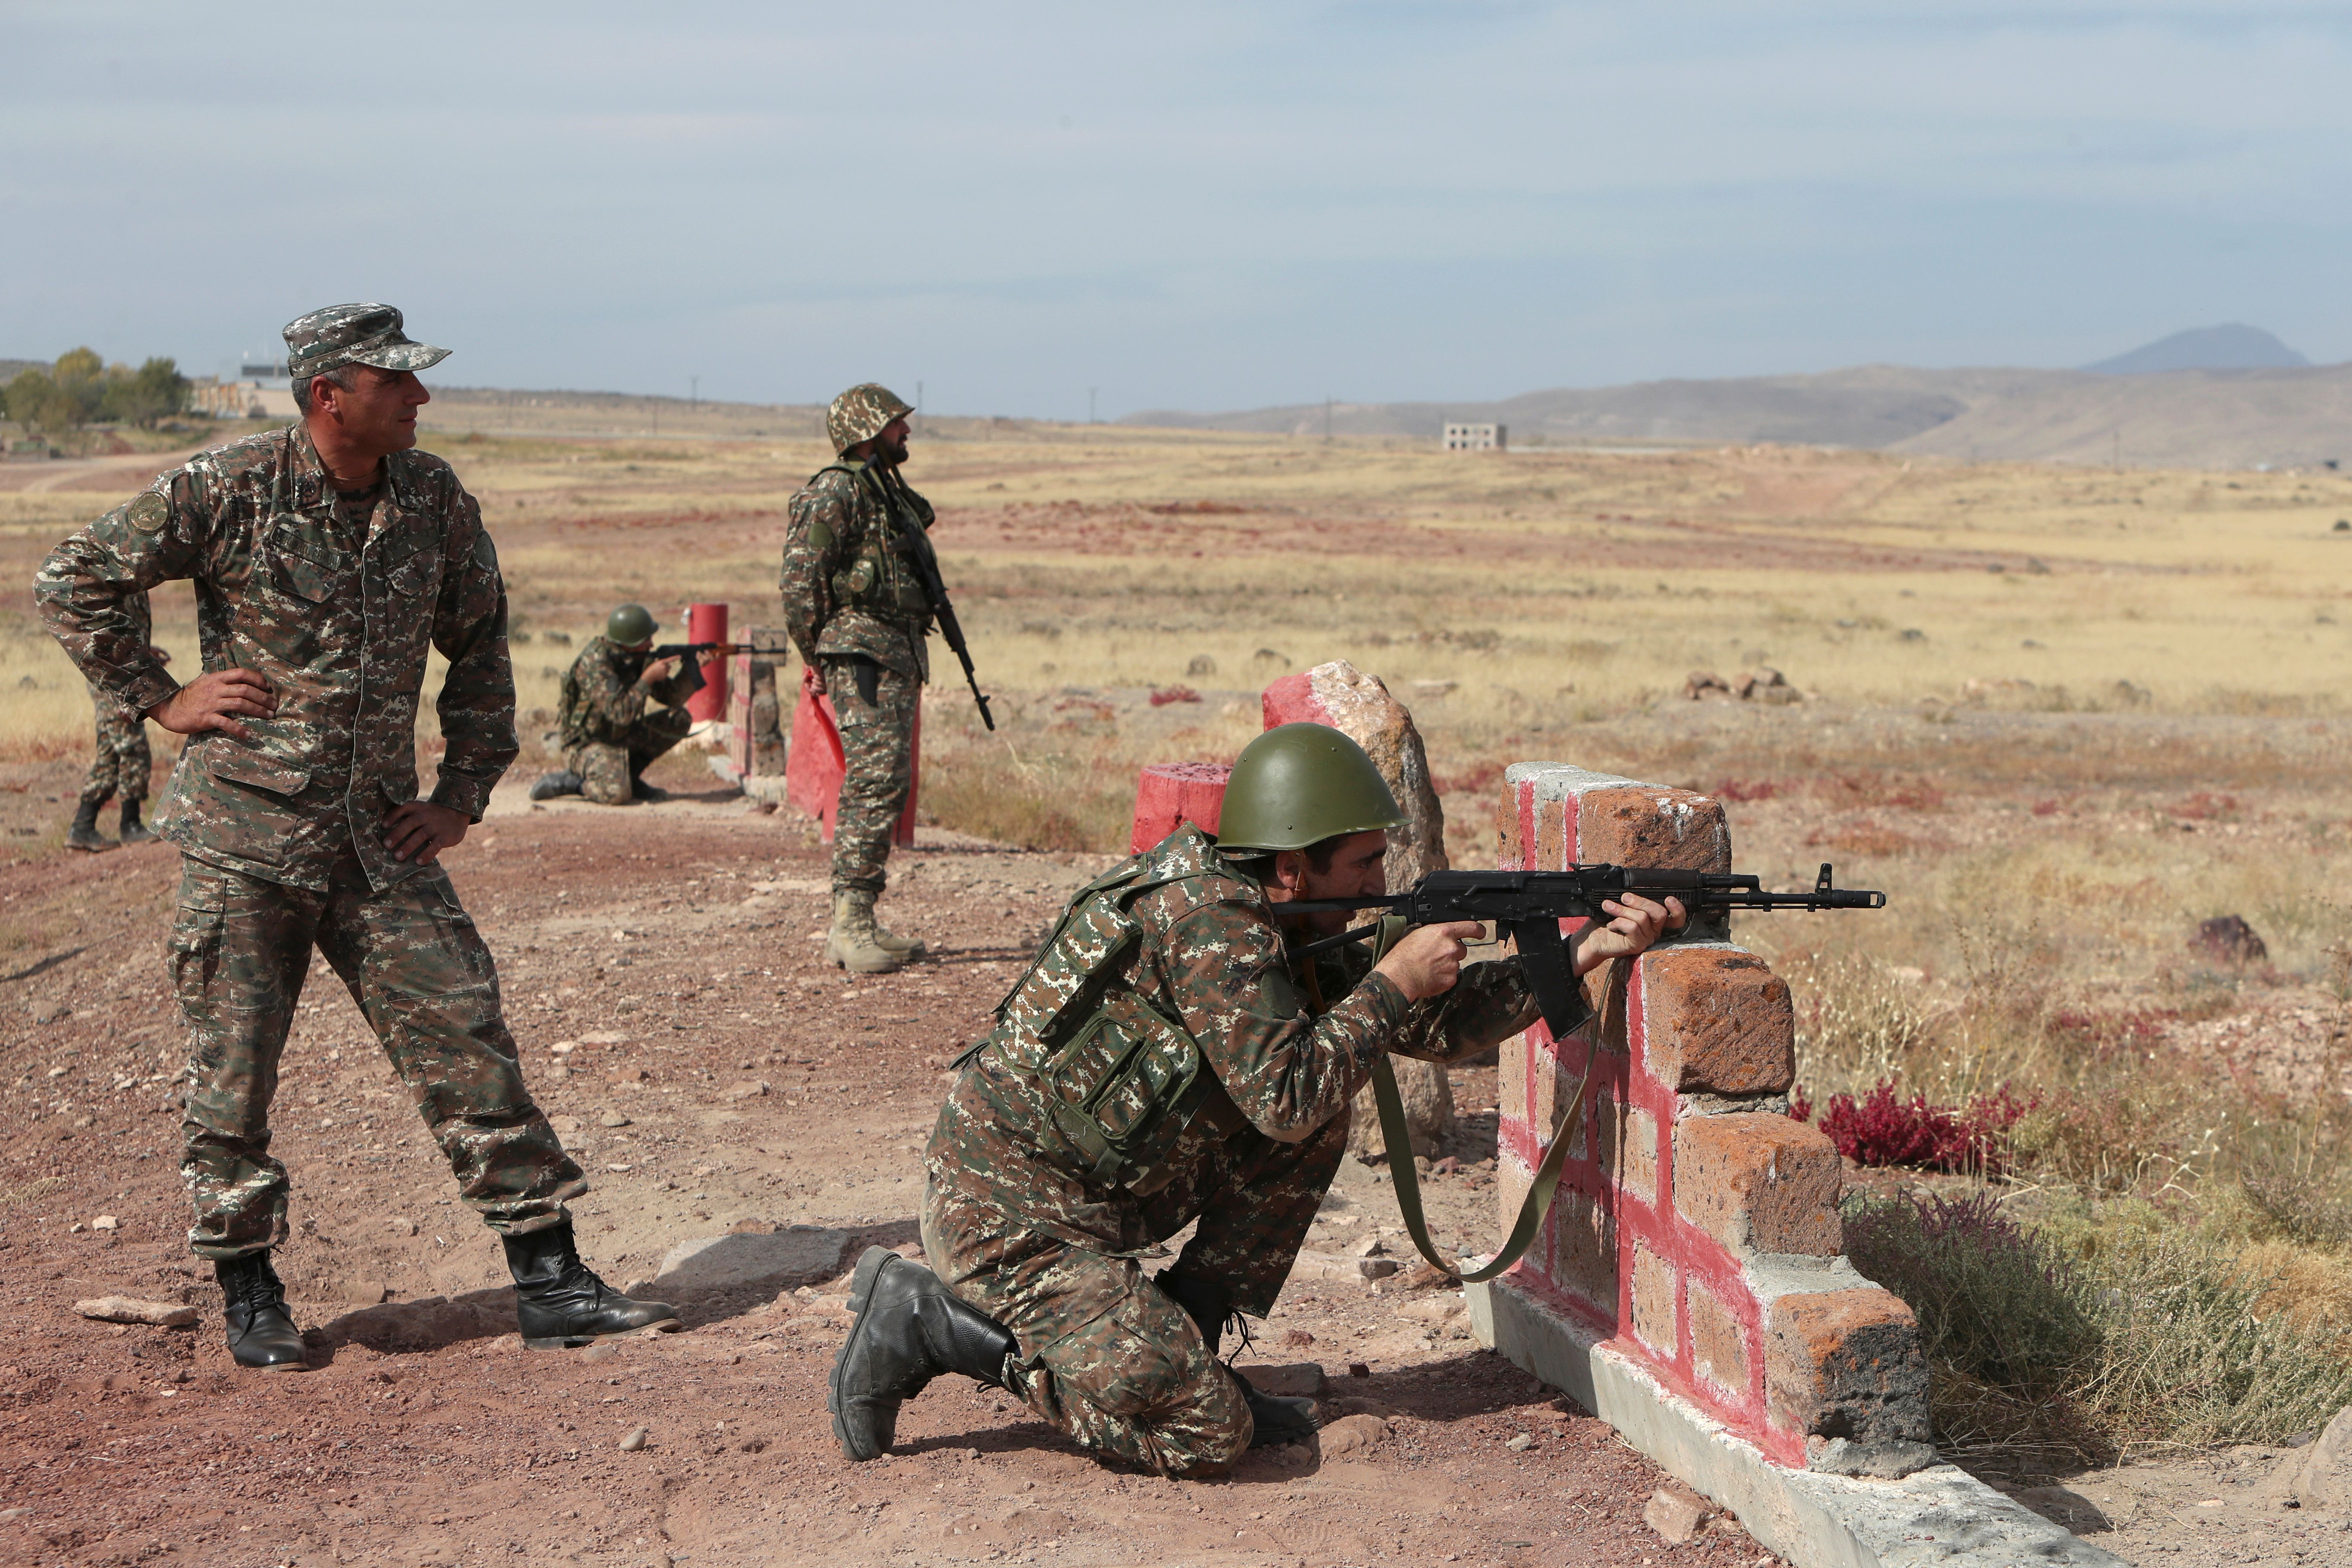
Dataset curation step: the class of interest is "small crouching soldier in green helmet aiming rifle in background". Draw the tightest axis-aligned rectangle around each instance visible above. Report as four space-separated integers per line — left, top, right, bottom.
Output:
532 604 703 806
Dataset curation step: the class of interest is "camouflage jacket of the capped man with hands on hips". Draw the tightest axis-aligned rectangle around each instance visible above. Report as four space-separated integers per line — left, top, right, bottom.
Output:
33 426 518 891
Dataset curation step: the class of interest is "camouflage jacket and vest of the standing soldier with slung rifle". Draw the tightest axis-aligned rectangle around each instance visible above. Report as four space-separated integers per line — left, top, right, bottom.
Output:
781 459 934 682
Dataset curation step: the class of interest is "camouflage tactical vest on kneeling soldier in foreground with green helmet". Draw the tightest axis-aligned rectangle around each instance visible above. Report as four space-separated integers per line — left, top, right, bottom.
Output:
974 823 1246 1194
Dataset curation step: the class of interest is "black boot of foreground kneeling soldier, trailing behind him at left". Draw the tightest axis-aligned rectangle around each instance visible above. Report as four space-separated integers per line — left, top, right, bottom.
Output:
826 1246 1018 1460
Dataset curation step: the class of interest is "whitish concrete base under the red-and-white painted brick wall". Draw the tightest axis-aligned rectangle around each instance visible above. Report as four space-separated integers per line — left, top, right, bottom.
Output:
1468 1279 2124 1568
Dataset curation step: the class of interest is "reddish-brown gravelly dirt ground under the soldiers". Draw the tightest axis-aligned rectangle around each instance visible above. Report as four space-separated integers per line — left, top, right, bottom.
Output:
0 760 1771 1568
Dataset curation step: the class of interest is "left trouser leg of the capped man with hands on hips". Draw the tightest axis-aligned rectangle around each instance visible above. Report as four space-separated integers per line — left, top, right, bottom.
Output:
167 861 322 1258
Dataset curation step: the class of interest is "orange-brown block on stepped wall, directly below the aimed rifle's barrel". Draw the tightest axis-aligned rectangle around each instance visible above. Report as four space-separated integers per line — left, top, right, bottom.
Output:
1642 945 1797 1096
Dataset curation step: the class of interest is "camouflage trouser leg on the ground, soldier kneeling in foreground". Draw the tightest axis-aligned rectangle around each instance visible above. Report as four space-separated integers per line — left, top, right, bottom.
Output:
922 1185 1251 1476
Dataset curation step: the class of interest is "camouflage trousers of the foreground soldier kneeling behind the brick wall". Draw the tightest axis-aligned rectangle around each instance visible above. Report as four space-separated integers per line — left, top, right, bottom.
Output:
922 1117 1348 1476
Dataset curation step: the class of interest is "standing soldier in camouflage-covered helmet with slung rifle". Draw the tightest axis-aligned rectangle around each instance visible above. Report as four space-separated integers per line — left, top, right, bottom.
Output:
783 381 934 973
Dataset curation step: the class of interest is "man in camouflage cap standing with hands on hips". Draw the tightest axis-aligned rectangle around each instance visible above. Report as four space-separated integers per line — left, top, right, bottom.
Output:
35 306 677 1371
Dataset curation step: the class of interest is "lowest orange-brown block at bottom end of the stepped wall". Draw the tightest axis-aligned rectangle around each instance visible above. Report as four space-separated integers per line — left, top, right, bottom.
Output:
1764 1286 1936 1476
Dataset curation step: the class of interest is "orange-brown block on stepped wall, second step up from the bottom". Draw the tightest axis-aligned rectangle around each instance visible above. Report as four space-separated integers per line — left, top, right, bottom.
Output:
1675 1112 1844 1258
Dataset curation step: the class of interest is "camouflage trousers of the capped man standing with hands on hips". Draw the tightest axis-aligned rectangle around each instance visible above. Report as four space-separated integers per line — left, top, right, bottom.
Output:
169 853 588 1258
